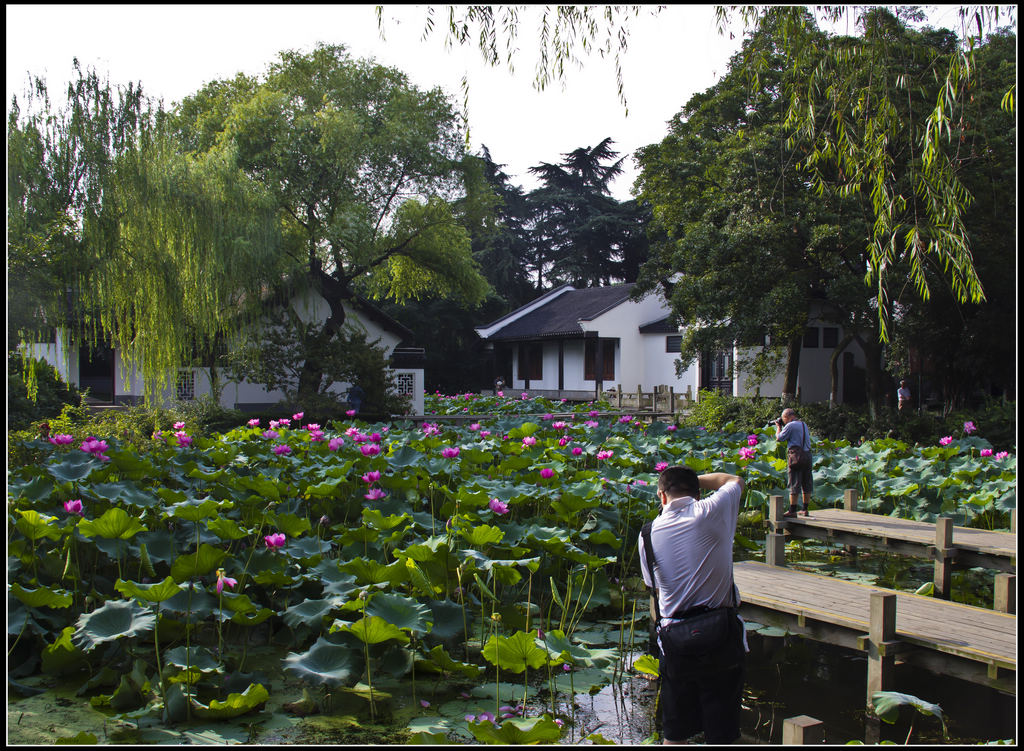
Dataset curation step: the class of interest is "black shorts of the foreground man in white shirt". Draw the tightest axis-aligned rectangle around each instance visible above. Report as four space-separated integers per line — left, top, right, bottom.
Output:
660 619 745 744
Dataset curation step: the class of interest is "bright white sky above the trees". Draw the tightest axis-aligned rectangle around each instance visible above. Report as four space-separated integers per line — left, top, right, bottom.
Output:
6 4 991 200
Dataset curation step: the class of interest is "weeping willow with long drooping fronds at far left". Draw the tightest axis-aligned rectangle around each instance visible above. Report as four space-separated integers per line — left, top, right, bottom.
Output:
7 60 280 401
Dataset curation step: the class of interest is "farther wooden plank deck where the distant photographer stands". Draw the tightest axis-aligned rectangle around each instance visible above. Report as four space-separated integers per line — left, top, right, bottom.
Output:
784 508 1017 574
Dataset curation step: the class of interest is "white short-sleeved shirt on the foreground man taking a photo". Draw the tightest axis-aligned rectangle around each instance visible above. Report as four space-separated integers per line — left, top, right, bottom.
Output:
640 482 742 623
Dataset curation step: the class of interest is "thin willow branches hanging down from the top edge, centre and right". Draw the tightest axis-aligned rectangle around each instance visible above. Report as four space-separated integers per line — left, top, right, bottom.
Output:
391 5 1016 341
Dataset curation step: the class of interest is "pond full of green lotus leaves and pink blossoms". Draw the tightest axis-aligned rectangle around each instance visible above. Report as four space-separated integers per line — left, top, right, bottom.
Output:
8 394 1016 743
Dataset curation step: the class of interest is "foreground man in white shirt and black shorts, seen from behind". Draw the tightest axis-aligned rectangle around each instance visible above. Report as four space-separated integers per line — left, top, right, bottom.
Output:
640 466 745 744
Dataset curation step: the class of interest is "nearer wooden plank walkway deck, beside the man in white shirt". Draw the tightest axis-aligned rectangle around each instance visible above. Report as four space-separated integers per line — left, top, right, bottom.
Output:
733 557 1017 693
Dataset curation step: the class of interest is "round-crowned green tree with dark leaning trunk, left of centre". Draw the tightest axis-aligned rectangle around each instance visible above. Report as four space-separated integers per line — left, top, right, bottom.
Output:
172 45 487 403
